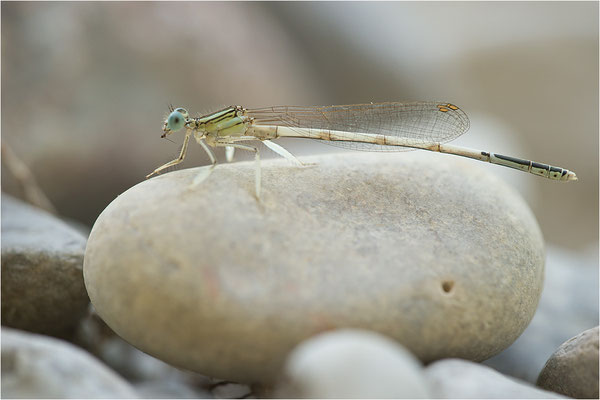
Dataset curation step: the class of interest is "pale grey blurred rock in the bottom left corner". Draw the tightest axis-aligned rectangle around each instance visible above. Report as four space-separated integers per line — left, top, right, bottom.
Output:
2 327 138 399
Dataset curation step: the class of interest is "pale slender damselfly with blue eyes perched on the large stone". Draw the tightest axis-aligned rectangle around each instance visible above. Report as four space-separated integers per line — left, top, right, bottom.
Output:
146 102 577 198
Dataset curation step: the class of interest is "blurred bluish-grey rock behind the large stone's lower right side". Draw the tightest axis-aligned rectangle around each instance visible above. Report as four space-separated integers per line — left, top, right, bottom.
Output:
483 246 599 383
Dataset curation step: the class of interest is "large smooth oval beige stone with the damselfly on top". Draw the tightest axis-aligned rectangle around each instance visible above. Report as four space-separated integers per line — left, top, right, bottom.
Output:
84 152 544 382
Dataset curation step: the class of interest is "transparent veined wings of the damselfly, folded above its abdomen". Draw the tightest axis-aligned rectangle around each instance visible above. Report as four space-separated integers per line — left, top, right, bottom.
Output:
247 102 469 151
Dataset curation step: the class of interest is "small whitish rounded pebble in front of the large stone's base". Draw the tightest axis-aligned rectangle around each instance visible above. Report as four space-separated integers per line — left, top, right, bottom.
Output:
276 329 431 398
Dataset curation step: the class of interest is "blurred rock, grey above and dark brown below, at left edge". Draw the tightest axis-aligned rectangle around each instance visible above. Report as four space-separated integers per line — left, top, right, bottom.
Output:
2 193 89 337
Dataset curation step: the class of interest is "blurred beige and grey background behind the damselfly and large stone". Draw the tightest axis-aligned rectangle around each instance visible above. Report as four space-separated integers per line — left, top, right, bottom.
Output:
1 2 599 255
